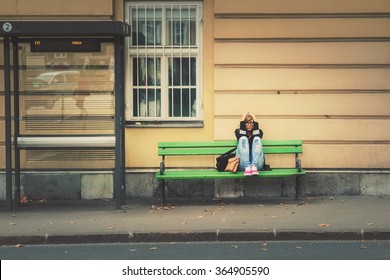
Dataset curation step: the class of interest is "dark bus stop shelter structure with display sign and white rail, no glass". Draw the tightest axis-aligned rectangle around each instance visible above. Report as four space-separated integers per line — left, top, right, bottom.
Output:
0 21 131 211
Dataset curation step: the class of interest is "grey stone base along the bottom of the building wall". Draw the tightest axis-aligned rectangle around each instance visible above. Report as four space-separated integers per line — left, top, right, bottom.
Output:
0 171 390 200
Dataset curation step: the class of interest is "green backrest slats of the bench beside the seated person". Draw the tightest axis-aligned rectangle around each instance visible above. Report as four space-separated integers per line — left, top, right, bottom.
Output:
158 140 303 156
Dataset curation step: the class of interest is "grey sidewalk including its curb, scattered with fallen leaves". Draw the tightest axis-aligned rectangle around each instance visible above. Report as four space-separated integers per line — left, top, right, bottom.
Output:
0 196 390 245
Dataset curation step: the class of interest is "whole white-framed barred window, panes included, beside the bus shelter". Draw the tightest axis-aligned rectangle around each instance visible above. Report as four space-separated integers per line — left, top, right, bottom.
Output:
127 2 202 121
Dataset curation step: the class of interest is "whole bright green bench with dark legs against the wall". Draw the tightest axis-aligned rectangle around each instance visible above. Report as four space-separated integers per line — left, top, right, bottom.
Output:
156 140 305 205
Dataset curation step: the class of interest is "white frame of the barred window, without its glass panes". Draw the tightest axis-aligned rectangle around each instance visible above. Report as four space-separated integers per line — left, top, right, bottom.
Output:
125 1 203 124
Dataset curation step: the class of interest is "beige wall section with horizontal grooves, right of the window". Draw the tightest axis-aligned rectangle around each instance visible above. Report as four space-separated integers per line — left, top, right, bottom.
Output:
214 0 390 168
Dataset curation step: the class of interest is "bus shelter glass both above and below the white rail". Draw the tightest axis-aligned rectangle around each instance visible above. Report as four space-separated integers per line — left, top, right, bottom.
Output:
19 42 115 169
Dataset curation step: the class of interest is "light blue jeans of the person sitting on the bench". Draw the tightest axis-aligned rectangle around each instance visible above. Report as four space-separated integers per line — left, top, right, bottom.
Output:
236 136 264 171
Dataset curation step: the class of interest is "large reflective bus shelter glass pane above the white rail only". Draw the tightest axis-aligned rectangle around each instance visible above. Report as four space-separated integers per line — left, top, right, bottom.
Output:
19 43 115 135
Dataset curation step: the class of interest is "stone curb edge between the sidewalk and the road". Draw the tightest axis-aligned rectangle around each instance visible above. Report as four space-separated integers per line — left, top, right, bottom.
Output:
0 229 390 246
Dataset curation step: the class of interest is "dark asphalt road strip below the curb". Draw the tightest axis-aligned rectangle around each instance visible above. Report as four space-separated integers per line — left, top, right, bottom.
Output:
0 240 390 260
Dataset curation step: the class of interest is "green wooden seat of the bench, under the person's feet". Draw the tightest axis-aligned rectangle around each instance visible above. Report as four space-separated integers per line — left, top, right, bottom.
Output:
156 168 305 180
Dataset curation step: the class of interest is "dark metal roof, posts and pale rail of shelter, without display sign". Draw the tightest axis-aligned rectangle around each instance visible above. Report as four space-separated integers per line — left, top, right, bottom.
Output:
0 21 131 211
